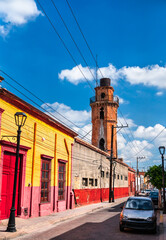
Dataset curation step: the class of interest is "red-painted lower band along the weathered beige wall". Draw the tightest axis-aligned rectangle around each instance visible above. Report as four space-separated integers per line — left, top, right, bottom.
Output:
74 187 129 205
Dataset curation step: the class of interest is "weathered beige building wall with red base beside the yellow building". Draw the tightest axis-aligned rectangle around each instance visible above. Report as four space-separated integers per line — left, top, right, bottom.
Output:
72 138 135 205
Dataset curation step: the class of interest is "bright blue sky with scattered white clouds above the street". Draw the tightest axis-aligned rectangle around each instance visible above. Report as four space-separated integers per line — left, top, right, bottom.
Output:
0 0 166 172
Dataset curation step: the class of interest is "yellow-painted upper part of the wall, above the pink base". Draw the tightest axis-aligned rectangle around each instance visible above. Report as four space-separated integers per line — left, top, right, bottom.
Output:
0 99 74 187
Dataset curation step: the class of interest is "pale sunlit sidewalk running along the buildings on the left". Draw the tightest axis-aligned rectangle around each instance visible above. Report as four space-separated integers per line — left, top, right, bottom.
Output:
0 197 128 239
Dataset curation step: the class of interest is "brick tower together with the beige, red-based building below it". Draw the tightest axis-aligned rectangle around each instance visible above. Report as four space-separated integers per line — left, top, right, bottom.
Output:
72 78 135 205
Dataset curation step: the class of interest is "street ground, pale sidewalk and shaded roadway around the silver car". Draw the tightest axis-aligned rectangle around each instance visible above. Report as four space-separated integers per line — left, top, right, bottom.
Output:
0 198 166 240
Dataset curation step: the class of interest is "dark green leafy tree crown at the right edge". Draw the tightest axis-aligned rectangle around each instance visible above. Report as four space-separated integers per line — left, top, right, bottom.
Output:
145 165 166 189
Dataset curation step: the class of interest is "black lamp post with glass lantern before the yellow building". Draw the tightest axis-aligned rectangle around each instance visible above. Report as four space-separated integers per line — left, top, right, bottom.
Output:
6 112 27 232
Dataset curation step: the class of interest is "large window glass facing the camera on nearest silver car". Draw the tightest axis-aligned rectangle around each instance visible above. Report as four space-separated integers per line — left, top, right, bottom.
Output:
125 199 153 210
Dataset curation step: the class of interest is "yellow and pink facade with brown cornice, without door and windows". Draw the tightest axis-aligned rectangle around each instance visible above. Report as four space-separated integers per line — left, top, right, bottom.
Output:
0 89 77 219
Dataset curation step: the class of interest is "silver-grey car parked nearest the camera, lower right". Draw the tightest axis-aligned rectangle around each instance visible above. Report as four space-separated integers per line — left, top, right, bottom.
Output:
119 197 157 233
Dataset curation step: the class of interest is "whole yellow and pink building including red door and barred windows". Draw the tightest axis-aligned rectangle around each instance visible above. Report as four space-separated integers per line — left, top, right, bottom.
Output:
0 88 77 219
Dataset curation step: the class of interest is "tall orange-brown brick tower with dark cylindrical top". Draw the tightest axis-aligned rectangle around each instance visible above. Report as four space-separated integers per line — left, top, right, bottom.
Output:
90 78 119 157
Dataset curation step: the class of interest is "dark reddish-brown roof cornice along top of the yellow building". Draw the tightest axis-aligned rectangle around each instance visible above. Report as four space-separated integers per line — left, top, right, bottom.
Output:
0 88 78 138
